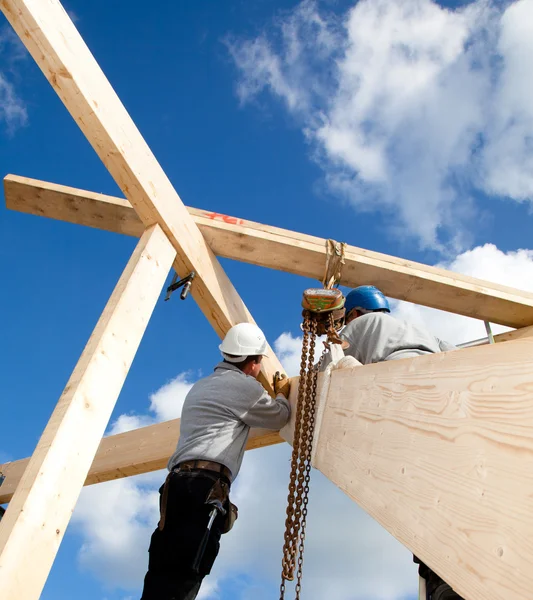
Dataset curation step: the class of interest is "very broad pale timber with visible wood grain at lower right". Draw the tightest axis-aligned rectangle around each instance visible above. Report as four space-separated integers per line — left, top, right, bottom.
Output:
314 337 533 600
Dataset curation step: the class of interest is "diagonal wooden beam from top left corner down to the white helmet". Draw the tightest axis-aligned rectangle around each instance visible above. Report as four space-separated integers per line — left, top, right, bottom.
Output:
0 0 283 392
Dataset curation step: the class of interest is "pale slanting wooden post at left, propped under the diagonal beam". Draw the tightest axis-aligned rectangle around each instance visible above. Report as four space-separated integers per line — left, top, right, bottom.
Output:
0 225 176 600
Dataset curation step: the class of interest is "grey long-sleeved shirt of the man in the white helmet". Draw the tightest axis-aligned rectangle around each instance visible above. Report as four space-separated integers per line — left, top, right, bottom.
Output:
168 362 290 479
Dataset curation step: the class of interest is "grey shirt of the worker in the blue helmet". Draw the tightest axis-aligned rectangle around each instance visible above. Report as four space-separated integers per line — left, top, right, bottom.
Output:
322 312 456 368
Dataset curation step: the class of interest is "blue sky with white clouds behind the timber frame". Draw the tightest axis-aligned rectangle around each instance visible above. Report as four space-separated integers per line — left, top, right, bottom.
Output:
0 0 533 600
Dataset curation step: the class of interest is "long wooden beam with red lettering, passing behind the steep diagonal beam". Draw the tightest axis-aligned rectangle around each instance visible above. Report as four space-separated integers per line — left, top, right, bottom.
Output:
4 175 533 327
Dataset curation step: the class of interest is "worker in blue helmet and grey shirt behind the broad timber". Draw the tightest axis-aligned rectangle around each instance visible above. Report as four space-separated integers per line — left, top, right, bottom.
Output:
322 285 462 600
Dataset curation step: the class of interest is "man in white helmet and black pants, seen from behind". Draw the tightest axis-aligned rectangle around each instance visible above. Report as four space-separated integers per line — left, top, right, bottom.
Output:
141 323 290 600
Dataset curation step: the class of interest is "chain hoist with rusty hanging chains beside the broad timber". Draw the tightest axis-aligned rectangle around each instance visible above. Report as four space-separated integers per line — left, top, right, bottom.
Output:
280 284 344 600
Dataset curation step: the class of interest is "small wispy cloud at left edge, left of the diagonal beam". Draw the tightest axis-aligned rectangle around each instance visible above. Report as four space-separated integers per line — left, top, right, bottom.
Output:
0 26 28 136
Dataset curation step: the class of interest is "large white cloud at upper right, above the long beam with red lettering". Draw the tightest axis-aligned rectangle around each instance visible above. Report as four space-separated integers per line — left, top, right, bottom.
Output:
228 0 533 248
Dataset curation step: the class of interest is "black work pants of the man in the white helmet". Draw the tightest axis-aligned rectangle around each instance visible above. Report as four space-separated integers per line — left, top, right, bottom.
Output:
141 470 227 600
